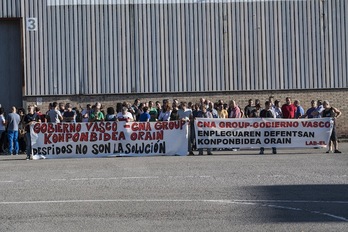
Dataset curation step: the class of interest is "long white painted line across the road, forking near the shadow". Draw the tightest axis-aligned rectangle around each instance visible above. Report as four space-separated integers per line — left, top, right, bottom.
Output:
0 199 348 222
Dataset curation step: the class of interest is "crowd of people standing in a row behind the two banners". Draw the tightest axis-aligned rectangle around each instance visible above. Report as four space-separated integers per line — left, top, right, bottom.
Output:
0 96 341 159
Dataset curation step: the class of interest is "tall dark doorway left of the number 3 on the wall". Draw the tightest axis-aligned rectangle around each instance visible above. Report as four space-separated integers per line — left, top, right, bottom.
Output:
0 19 23 112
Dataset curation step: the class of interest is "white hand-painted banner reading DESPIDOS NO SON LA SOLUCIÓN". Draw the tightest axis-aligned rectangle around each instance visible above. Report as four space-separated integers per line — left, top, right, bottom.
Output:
30 121 188 159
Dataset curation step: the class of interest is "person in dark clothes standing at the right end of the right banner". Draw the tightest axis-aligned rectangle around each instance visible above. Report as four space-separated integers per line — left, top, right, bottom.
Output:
321 101 342 153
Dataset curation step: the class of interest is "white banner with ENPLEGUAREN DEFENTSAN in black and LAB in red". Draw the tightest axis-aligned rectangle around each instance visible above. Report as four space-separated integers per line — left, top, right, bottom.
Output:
195 118 333 148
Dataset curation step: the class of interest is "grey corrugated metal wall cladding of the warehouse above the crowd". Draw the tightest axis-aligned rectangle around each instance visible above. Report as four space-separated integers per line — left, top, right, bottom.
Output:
0 0 348 96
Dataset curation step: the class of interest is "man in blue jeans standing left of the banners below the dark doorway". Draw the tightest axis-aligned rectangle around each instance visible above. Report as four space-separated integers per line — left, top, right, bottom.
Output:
6 106 21 155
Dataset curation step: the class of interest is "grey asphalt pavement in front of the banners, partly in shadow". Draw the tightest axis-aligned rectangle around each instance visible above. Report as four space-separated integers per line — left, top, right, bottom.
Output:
0 144 348 232
